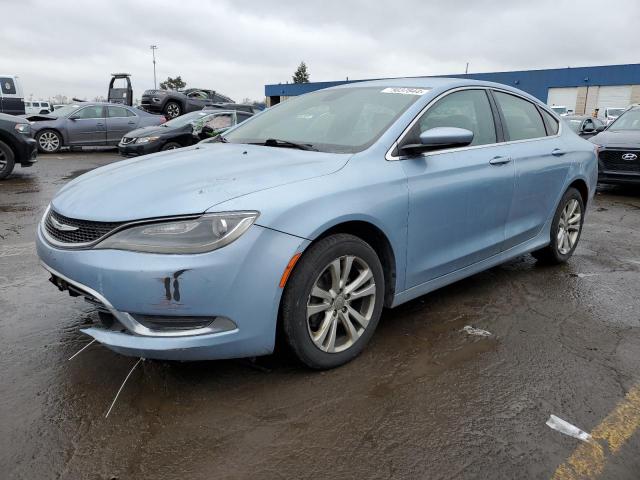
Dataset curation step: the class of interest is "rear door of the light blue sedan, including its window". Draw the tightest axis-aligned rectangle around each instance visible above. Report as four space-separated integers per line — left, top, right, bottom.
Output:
493 91 572 250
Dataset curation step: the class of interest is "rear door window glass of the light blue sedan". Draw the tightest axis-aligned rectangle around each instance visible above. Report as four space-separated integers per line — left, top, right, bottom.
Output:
494 92 547 141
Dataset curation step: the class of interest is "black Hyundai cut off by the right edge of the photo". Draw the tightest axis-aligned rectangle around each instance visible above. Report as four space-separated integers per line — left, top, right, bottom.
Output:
589 106 640 184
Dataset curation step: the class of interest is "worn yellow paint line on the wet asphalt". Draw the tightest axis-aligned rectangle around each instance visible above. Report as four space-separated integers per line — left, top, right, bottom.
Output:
552 385 640 480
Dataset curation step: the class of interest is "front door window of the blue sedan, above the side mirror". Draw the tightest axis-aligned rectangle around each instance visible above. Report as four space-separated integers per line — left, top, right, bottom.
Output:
411 90 496 145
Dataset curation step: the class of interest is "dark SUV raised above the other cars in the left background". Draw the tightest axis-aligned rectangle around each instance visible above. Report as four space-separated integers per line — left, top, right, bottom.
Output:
140 88 233 120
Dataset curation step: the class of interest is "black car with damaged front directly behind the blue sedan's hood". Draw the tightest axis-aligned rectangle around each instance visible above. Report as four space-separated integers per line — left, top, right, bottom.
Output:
118 110 253 157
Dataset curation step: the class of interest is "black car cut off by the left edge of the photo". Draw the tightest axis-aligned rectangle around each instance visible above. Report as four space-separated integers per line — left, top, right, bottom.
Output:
0 113 38 180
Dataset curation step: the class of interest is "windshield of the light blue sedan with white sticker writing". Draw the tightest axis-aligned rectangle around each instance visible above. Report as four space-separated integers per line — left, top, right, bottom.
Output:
225 87 429 153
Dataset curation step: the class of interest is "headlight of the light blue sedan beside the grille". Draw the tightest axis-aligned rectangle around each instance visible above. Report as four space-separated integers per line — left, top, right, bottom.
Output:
95 212 259 254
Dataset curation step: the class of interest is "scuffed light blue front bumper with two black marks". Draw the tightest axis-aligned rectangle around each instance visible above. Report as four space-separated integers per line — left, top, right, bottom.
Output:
37 225 312 360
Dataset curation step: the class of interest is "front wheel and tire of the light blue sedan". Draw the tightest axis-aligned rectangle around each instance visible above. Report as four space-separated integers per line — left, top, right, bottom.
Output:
281 233 384 369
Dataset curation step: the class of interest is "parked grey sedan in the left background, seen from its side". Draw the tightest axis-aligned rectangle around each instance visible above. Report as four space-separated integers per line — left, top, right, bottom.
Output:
27 102 166 153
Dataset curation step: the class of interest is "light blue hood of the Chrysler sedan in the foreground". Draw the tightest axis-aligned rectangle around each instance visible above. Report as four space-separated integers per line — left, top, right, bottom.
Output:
51 143 351 222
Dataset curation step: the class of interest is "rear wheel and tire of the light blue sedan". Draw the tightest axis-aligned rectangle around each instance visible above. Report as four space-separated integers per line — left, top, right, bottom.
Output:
532 188 584 265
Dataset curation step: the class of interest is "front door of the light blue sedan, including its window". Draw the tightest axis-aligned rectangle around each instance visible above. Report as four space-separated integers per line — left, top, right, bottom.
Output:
400 89 514 288
